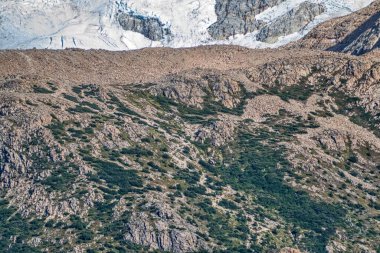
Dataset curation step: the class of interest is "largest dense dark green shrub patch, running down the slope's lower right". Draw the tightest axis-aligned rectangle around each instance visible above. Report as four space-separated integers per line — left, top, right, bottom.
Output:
205 122 345 252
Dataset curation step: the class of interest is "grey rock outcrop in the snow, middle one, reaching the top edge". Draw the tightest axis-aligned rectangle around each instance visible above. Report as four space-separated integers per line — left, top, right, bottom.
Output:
208 0 284 39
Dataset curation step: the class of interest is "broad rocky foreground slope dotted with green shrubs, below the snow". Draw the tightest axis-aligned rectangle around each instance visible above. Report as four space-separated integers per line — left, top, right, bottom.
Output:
0 46 380 252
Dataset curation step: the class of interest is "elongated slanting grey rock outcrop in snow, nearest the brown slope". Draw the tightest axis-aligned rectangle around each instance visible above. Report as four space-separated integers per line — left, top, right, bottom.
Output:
257 2 326 43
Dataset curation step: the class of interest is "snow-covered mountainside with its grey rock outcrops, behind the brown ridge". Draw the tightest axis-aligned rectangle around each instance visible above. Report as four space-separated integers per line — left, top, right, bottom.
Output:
0 0 373 50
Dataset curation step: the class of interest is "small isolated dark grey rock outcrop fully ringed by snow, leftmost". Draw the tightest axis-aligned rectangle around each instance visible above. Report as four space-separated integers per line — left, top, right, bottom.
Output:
118 12 170 41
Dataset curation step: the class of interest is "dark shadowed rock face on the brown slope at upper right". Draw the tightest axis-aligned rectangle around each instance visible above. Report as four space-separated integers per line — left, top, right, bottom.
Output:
329 13 380 55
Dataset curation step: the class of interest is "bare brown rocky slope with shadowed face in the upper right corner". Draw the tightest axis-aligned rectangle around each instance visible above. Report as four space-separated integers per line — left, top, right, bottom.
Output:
288 1 380 55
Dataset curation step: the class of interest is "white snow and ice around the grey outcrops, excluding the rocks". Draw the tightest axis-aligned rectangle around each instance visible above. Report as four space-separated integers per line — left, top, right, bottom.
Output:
0 0 373 50
